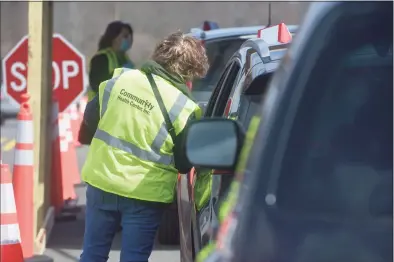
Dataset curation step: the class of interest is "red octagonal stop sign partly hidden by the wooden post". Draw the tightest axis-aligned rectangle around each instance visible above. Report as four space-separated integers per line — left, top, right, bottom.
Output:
2 34 87 112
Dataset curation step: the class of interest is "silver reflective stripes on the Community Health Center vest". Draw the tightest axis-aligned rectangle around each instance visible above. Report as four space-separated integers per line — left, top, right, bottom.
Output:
94 68 188 165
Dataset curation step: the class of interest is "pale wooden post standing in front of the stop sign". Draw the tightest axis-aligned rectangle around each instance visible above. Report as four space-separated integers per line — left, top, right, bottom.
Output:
27 1 53 253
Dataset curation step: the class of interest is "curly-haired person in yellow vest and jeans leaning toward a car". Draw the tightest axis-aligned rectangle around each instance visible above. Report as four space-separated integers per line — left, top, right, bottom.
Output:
80 32 208 262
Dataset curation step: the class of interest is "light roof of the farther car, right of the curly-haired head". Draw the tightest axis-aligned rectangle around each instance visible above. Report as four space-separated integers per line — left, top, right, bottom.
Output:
188 25 298 41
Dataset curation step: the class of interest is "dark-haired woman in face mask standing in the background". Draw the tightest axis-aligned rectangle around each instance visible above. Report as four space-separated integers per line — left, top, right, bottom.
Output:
88 21 134 101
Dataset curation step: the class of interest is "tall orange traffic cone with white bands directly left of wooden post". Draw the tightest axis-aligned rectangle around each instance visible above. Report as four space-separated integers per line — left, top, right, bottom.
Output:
13 94 34 258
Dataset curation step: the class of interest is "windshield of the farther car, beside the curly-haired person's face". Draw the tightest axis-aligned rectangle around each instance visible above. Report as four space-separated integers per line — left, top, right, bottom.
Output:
192 38 246 102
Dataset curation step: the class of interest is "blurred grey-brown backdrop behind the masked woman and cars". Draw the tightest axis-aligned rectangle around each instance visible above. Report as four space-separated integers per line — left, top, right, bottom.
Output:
0 2 309 63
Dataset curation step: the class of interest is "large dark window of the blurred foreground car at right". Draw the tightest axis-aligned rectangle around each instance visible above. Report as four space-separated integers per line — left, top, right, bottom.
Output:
276 17 393 221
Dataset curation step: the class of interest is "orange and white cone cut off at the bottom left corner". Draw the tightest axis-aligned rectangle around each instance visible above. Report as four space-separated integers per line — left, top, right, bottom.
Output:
0 163 23 262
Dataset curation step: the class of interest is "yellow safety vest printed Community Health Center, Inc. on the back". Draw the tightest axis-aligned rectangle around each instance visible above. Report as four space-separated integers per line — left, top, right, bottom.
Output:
82 68 201 203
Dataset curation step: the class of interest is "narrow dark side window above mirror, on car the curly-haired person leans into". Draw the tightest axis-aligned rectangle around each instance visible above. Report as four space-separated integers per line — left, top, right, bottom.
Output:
212 61 241 116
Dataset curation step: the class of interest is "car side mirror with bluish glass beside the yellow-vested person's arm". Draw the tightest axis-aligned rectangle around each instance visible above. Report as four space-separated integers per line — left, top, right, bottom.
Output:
185 118 245 170
